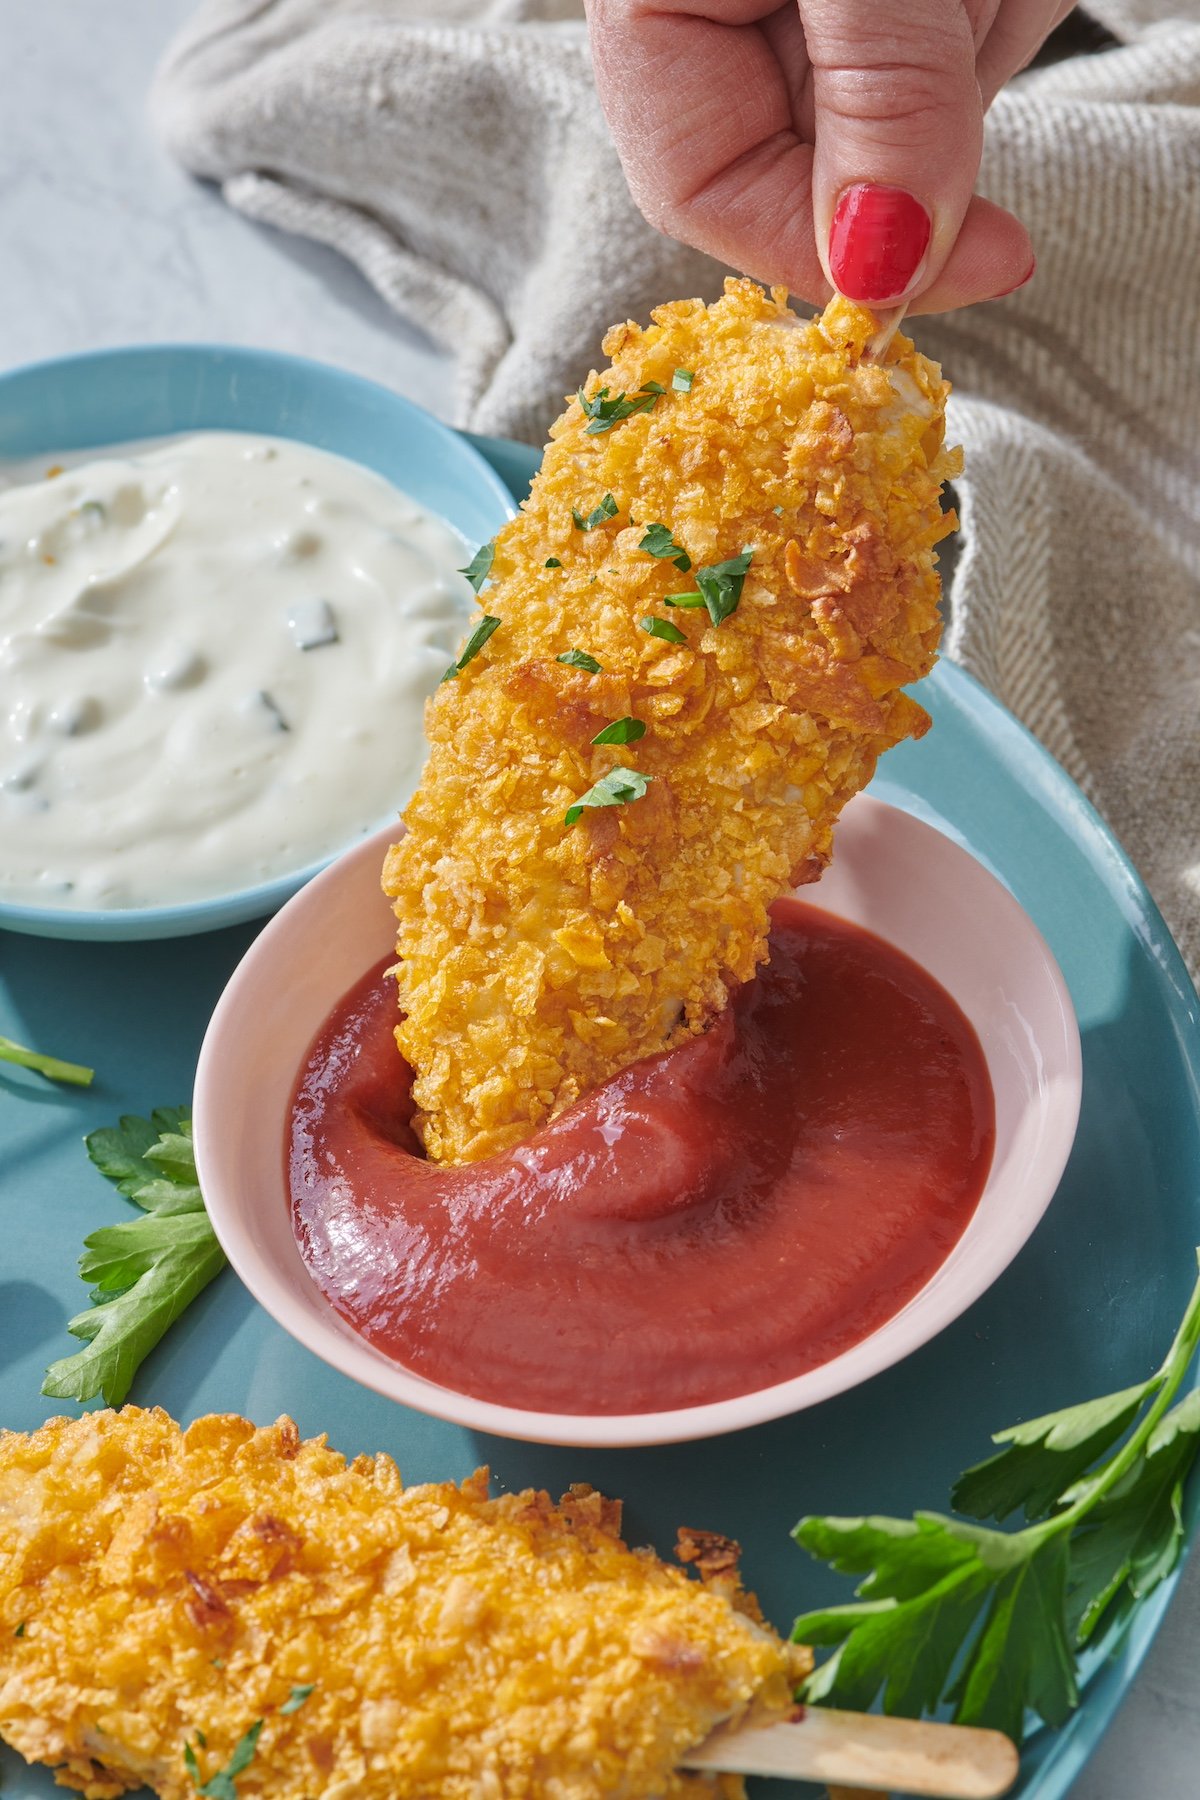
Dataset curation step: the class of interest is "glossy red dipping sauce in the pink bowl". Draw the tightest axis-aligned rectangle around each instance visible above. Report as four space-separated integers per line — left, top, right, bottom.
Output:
286 900 995 1413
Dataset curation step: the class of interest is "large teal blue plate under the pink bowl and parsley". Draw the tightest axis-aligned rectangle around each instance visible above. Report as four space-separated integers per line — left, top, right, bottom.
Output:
0 443 1200 1800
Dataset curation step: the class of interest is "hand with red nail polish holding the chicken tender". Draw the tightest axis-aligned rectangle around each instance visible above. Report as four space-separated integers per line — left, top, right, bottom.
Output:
588 0 1070 313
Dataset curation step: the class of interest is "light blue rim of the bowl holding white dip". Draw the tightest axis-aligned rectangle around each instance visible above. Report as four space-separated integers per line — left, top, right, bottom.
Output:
0 338 516 941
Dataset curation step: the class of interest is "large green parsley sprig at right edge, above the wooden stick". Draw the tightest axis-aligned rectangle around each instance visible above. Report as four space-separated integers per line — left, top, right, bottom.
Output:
793 1252 1200 1741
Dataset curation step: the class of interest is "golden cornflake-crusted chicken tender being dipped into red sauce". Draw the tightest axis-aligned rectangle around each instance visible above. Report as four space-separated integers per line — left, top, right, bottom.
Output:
383 281 959 1163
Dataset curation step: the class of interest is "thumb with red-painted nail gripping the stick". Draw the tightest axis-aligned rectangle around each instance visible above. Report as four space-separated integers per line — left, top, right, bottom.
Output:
799 0 984 306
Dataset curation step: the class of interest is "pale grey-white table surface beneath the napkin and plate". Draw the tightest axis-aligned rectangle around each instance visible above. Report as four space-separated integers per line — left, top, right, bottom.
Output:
0 0 1200 1800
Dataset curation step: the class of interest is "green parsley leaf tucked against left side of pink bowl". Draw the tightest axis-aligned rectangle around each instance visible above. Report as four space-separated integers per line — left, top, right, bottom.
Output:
41 1107 225 1406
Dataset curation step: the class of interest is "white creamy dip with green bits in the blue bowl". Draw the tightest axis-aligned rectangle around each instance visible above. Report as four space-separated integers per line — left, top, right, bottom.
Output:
0 432 475 907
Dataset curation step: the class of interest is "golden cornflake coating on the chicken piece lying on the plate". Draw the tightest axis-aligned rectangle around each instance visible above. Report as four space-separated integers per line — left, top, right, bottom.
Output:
0 1406 811 1800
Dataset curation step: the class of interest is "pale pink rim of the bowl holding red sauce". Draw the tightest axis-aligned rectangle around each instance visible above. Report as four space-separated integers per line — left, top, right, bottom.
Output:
194 796 1083 1449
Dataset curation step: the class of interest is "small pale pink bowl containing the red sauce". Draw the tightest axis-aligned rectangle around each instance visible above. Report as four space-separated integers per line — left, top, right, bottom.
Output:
194 796 1081 1445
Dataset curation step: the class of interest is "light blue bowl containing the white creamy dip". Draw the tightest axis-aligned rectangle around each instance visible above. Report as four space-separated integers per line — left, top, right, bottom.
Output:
0 344 513 941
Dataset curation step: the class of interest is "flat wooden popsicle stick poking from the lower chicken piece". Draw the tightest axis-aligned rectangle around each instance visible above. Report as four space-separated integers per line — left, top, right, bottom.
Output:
682 1706 1020 1800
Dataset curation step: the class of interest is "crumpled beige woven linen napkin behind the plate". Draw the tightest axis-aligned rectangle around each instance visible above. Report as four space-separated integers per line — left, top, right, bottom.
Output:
153 0 1200 974
